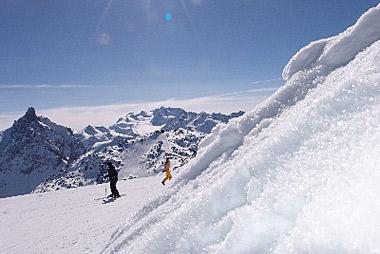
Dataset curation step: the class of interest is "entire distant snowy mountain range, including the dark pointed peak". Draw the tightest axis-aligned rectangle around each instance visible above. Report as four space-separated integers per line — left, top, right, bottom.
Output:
0 107 244 197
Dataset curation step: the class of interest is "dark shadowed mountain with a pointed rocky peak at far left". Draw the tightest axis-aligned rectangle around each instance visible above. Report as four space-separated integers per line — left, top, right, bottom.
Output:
0 108 85 197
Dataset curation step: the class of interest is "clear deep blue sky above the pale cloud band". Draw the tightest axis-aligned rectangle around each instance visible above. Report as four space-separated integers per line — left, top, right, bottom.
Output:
0 0 378 129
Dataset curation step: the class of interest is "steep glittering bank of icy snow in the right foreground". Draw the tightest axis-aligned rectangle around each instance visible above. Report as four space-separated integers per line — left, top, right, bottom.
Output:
103 5 380 253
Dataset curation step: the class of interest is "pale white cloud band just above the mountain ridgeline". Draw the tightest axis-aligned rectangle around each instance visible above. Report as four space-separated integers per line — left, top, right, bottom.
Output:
0 88 276 131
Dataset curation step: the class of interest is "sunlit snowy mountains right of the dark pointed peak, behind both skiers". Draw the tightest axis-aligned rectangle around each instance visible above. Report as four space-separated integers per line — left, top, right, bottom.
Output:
36 107 243 192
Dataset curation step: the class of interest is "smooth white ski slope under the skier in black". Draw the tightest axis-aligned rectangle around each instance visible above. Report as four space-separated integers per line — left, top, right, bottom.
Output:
0 177 165 253
